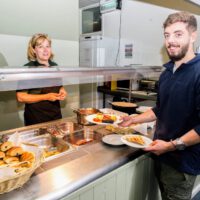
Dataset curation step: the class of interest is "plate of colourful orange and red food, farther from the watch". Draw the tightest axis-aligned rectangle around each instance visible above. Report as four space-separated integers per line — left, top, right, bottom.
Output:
85 113 122 125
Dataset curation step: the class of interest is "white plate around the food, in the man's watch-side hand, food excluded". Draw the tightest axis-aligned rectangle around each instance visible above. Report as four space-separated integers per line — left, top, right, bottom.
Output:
121 134 152 149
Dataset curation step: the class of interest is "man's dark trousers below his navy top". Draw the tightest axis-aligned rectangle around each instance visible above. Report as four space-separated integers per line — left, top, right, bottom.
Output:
155 160 196 200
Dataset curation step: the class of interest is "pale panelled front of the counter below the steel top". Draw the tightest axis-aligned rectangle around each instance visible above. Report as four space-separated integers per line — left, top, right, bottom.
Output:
62 155 161 200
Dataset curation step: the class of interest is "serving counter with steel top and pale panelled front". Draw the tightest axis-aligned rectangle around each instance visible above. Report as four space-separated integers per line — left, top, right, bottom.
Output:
0 108 199 200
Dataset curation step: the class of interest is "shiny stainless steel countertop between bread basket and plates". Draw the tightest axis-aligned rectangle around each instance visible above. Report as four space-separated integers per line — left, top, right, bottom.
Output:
0 126 147 200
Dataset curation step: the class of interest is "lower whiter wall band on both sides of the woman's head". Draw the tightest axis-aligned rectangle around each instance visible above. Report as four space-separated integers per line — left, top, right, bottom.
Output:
0 34 79 67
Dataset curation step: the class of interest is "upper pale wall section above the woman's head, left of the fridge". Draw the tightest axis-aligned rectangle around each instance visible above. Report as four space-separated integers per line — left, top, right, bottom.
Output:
0 0 79 41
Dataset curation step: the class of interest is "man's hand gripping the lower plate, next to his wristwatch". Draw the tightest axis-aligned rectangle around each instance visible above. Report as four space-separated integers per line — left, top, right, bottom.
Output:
143 140 175 155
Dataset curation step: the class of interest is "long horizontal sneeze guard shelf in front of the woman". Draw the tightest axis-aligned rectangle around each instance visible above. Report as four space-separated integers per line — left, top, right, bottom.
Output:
0 66 148 91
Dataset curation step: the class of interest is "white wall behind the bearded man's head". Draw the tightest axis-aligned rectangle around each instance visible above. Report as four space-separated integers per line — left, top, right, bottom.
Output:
121 0 200 65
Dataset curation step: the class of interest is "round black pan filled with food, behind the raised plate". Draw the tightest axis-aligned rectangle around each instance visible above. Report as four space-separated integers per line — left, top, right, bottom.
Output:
111 101 138 115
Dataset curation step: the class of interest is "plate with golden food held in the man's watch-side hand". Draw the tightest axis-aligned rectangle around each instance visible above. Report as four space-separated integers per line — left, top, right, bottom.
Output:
121 134 153 149
